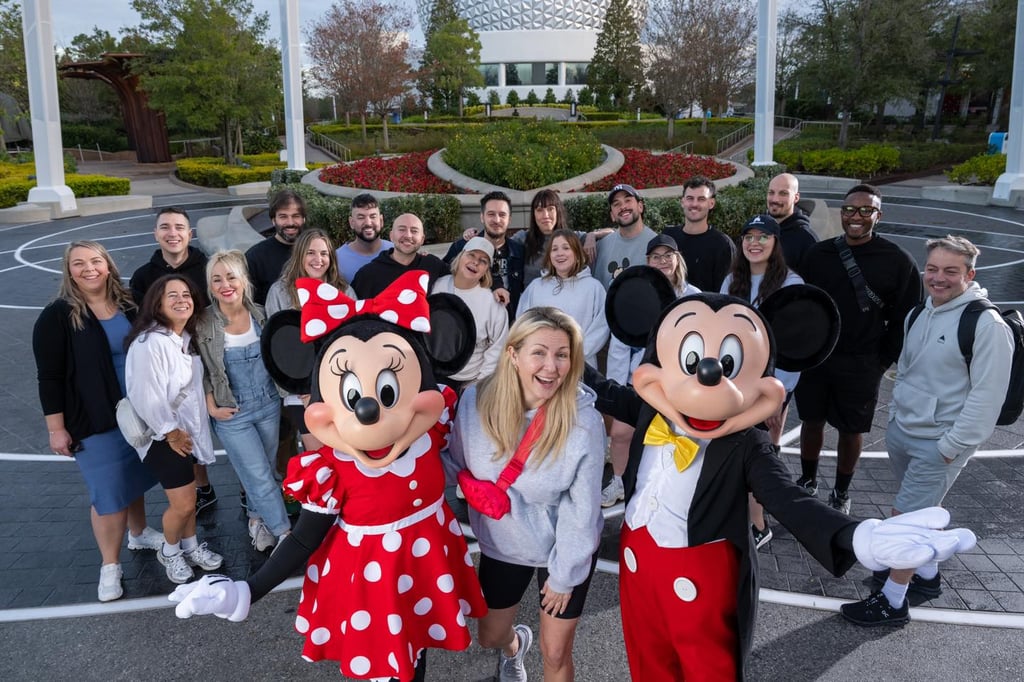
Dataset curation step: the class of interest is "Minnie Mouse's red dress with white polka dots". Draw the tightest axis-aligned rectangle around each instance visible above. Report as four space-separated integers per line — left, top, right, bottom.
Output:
285 392 486 680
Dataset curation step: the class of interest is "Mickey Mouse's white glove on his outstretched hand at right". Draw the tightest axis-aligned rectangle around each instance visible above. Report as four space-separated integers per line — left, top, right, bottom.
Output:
853 507 978 570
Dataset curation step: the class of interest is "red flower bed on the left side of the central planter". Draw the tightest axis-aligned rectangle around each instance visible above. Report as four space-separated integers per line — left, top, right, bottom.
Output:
319 152 459 195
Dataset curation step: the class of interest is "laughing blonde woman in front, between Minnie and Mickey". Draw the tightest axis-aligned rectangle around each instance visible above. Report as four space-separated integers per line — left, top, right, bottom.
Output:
450 307 604 682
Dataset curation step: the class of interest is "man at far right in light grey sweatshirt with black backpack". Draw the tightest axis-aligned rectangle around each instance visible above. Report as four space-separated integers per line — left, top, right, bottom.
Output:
842 236 1014 626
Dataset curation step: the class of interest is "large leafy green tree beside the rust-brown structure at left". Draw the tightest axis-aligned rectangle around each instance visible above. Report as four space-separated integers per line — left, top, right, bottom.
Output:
129 0 283 163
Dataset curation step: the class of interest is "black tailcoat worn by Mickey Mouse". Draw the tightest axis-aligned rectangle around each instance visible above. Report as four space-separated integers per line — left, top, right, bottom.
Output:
584 367 857 670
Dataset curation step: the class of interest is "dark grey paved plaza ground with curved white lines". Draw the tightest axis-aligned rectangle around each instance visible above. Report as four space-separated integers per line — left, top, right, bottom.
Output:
0 161 1024 680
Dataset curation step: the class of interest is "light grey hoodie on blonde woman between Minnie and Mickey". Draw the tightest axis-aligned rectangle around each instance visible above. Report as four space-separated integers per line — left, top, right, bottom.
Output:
446 384 604 593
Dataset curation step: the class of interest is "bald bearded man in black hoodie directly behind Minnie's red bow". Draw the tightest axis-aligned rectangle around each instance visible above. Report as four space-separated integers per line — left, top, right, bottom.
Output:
352 213 449 298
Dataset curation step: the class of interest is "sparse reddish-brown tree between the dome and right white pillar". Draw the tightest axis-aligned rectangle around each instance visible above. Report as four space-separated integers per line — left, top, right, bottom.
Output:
647 0 756 141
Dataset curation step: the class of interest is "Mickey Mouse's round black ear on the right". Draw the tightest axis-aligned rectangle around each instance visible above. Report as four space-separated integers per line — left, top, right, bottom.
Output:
758 285 840 372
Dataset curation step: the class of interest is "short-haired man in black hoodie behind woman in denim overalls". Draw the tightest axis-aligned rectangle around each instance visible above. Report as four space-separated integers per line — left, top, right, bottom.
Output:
128 206 210 308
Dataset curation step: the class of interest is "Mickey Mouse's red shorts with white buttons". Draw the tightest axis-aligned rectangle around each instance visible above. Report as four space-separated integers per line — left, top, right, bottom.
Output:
618 523 740 682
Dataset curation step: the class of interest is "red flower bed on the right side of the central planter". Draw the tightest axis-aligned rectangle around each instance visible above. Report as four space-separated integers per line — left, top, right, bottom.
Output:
582 150 736 191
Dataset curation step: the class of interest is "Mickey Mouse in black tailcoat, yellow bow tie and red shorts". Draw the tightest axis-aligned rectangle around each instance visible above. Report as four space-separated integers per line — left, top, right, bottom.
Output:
584 266 975 682
